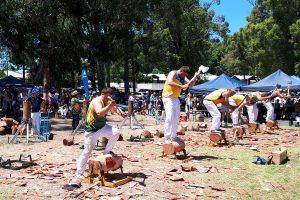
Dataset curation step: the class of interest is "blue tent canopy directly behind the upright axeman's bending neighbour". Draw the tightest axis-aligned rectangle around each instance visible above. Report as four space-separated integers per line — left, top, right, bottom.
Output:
190 74 246 93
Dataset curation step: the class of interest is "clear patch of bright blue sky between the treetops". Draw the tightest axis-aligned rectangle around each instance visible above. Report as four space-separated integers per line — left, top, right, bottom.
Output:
212 0 253 35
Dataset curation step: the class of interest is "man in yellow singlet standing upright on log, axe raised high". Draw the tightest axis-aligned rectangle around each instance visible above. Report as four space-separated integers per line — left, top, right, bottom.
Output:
162 66 208 143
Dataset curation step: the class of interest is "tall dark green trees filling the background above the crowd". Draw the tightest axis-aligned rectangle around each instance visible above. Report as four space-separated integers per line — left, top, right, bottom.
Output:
0 0 300 92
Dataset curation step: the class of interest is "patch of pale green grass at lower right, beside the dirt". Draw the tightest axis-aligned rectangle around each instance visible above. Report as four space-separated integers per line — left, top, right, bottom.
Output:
185 141 300 199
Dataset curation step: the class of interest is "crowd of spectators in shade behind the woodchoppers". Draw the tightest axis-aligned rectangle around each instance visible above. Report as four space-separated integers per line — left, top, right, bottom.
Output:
0 87 300 130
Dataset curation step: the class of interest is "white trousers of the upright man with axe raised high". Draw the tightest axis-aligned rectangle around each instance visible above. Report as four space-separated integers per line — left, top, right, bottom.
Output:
163 97 180 142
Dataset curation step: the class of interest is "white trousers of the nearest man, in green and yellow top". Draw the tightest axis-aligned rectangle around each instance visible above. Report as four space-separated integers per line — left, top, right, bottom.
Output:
76 124 120 177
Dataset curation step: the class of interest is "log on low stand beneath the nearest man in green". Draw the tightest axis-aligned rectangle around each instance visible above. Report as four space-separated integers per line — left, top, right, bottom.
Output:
88 154 123 177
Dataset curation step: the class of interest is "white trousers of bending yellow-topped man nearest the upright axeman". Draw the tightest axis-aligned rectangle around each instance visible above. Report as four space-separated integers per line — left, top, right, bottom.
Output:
203 100 221 131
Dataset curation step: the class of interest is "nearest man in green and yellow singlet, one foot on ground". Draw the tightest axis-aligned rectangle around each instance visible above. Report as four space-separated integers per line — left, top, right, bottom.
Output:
70 88 124 185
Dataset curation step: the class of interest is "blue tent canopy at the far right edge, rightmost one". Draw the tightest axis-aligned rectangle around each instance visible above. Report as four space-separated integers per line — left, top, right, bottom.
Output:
242 69 300 91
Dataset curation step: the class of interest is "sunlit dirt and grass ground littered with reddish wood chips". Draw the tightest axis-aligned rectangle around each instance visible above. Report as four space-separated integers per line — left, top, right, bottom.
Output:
0 116 300 200
